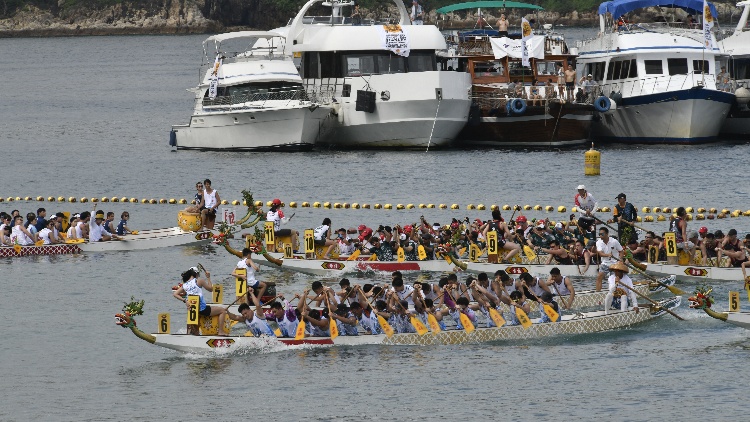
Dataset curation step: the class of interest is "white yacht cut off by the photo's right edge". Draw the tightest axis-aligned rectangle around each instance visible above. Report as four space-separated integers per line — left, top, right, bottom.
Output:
719 1 750 139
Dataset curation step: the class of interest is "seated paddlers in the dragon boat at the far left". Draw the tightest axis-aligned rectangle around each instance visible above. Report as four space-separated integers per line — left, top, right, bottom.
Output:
0 205 131 246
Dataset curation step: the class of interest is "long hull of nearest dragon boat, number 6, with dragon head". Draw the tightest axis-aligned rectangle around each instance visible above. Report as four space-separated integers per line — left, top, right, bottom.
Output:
115 296 681 354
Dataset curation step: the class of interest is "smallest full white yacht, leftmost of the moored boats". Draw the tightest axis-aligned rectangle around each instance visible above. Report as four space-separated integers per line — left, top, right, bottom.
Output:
170 31 335 151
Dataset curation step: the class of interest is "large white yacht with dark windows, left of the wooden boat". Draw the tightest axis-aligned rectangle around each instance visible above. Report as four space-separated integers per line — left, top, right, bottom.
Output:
274 0 471 149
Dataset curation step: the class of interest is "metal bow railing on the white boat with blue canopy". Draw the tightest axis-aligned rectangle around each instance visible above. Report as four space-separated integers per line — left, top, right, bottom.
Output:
597 73 716 98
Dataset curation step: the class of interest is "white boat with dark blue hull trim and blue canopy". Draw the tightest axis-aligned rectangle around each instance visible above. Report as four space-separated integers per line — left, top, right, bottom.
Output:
577 0 734 143
